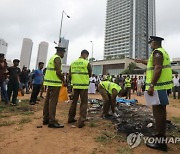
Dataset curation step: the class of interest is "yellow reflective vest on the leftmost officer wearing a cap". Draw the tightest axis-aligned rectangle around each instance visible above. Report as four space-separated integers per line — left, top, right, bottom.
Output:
43 54 62 87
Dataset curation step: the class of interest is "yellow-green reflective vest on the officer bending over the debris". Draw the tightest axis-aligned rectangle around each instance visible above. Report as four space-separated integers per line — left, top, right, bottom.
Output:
100 81 121 95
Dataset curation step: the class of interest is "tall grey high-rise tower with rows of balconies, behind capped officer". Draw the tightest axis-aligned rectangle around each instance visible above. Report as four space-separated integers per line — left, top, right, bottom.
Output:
104 0 155 59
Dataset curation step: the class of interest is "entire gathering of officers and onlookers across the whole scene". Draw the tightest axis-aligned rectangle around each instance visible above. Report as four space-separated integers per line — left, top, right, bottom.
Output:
0 36 180 151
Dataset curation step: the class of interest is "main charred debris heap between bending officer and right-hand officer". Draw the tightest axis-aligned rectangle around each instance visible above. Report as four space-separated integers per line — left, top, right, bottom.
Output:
116 104 155 135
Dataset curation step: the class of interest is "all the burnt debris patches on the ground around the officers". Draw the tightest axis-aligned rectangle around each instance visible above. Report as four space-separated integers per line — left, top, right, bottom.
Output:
88 99 180 136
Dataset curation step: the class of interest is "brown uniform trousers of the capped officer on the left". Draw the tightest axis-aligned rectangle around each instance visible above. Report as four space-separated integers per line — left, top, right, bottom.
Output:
43 86 60 124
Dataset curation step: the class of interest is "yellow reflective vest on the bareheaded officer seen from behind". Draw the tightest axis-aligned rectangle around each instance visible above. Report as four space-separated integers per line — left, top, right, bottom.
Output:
71 58 89 89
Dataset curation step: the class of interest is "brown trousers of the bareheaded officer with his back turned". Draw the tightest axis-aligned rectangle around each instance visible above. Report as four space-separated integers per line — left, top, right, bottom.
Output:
69 89 88 122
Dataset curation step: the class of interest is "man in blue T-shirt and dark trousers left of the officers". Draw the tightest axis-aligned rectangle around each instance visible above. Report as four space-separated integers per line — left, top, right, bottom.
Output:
29 62 44 105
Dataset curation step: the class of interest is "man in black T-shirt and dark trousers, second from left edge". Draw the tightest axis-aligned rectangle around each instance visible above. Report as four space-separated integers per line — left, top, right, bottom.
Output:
7 59 21 105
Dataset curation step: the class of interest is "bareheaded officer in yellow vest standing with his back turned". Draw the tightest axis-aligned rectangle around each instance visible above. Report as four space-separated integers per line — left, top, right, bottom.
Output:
68 50 92 128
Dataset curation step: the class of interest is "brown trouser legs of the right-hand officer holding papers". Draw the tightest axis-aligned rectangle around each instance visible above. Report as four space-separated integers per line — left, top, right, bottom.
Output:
152 105 166 137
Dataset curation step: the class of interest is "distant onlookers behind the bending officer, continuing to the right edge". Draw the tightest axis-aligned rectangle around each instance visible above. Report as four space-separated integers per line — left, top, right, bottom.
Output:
88 73 180 99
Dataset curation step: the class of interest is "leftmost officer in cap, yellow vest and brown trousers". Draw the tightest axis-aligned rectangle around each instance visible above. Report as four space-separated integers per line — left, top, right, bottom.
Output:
43 47 66 128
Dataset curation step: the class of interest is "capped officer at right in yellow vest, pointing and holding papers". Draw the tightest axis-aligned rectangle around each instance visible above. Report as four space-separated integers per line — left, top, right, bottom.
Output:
136 36 173 151
